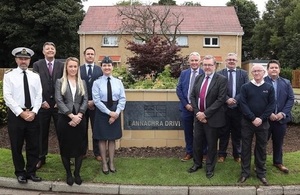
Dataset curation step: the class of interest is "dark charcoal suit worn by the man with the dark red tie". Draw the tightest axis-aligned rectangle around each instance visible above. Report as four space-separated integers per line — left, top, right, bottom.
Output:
190 73 227 174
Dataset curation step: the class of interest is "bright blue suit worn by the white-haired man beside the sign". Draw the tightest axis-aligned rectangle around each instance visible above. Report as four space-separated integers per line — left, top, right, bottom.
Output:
176 68 204 156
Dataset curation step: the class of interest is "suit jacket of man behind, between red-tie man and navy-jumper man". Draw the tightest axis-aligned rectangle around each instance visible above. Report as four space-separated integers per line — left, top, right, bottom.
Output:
218 68 249 103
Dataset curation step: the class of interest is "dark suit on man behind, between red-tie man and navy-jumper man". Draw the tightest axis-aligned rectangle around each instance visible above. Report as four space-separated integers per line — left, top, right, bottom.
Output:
218 68 249 158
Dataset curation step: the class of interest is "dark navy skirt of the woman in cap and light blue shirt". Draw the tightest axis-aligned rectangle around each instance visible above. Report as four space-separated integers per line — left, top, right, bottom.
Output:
93 102 122 140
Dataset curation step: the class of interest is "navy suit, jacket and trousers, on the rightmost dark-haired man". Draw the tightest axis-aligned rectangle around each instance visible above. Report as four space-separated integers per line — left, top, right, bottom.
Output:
264 76 294 164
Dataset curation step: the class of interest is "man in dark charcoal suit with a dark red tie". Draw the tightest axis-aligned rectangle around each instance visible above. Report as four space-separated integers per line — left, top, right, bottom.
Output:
188 55 227 178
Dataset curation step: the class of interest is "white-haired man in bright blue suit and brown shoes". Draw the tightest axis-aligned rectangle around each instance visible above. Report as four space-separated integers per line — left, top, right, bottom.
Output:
176 52 204 162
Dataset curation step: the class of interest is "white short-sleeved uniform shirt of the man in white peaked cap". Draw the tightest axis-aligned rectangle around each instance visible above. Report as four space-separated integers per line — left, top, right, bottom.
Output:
3 67 42 116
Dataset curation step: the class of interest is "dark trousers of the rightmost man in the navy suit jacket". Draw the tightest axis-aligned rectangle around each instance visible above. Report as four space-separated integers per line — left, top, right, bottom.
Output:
268 121 287 164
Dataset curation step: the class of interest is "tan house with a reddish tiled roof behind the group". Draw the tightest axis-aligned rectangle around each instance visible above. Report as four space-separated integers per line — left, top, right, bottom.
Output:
78 6 244 68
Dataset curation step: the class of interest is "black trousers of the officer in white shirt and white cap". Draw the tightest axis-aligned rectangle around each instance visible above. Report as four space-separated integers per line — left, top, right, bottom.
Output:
7 110 39 177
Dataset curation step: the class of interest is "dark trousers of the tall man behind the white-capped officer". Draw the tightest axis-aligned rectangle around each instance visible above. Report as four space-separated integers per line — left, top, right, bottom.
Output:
39 104 58 161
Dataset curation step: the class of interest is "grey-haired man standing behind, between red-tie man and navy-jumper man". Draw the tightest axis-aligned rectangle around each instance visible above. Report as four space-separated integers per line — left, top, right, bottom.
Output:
218 53 249 163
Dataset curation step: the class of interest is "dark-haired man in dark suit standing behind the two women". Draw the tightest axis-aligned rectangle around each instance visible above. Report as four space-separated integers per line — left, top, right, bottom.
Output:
80 47 102 161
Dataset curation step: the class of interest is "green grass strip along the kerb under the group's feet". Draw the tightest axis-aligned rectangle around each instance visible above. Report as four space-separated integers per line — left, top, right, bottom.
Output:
0 149 300 186
